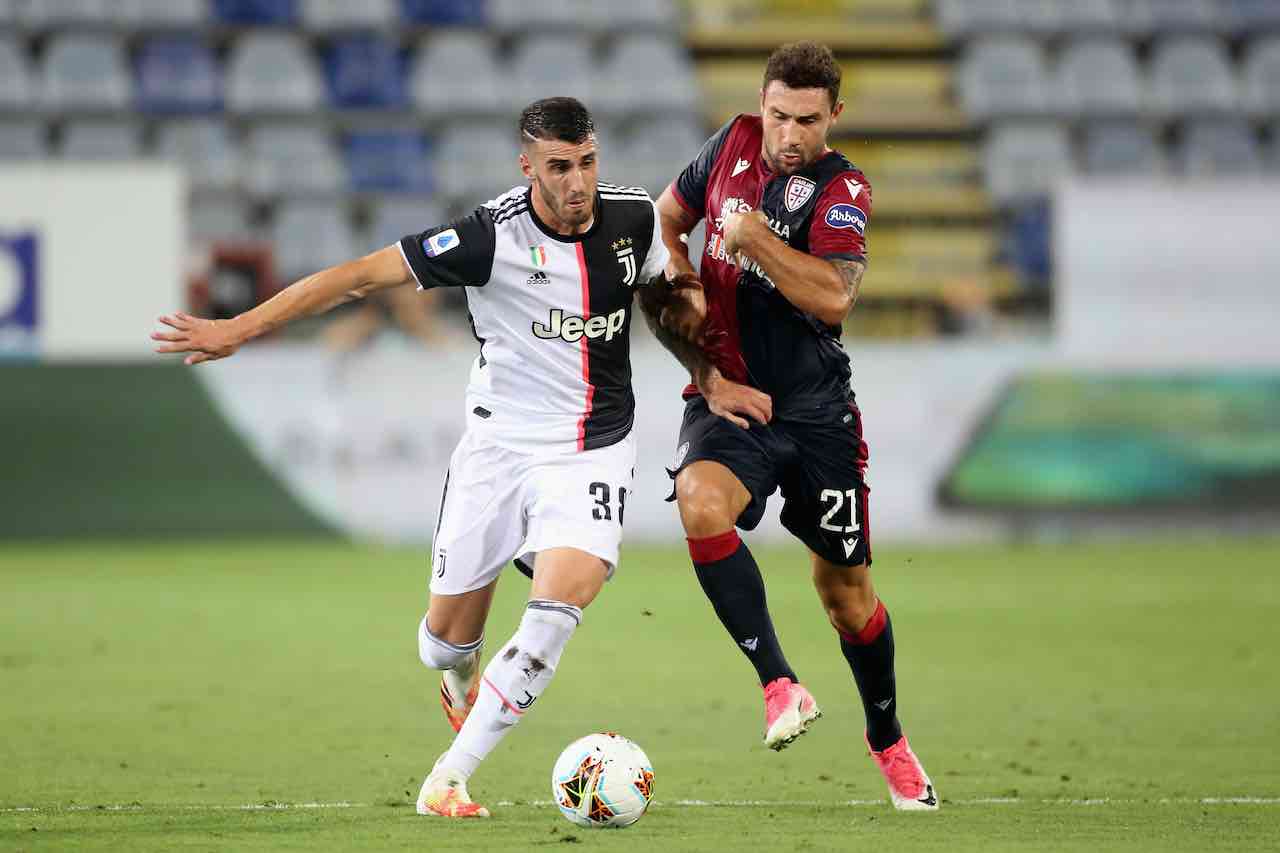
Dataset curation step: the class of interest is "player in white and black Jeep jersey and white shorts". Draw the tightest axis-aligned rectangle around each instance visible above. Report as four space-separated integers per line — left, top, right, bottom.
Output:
152 97 678 817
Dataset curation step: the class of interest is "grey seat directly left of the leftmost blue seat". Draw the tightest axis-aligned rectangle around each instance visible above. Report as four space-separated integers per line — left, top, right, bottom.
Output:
41 35 132 110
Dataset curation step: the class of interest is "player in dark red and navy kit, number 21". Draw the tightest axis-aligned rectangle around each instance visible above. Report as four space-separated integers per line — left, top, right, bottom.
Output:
646 42 938 809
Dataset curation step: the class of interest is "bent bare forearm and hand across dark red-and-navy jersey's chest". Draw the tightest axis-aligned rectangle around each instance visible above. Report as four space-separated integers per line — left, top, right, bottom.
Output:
723 210 867 325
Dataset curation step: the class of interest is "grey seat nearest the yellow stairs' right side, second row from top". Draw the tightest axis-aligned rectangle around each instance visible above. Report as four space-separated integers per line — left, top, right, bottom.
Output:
960 38 1050 120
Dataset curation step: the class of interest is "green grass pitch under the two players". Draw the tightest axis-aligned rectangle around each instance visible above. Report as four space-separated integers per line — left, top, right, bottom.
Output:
0 537 1280 853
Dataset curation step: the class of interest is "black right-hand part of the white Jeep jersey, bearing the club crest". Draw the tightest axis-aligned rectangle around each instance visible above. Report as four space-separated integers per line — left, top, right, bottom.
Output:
582 193 654 450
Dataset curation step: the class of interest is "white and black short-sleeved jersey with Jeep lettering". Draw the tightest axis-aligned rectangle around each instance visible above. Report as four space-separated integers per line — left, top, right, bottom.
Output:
399 183 668 451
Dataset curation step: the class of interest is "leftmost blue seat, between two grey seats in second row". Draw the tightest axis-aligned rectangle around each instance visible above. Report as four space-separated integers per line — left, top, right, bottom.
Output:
137 36 223 113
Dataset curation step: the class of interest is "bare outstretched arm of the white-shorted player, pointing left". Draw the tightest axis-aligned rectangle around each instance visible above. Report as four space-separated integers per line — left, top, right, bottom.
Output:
151 246 415 364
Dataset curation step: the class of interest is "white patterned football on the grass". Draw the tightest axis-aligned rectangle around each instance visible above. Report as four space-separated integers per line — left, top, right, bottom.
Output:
552 731 653 827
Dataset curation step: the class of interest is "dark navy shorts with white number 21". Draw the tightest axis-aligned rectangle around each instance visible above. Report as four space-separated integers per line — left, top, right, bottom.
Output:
667 397 872 566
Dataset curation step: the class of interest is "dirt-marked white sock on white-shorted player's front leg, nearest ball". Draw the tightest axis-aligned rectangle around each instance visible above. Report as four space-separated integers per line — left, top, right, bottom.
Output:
438 598 582 777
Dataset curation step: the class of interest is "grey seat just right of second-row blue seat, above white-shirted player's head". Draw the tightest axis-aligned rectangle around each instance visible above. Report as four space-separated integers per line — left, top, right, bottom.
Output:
408 32 506 115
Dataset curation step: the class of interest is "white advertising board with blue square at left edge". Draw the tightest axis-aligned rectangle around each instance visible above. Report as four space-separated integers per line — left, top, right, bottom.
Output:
0 163 187 361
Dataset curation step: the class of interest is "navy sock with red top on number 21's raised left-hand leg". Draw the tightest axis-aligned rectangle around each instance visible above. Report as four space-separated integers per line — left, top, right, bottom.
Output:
689 530 797 685
